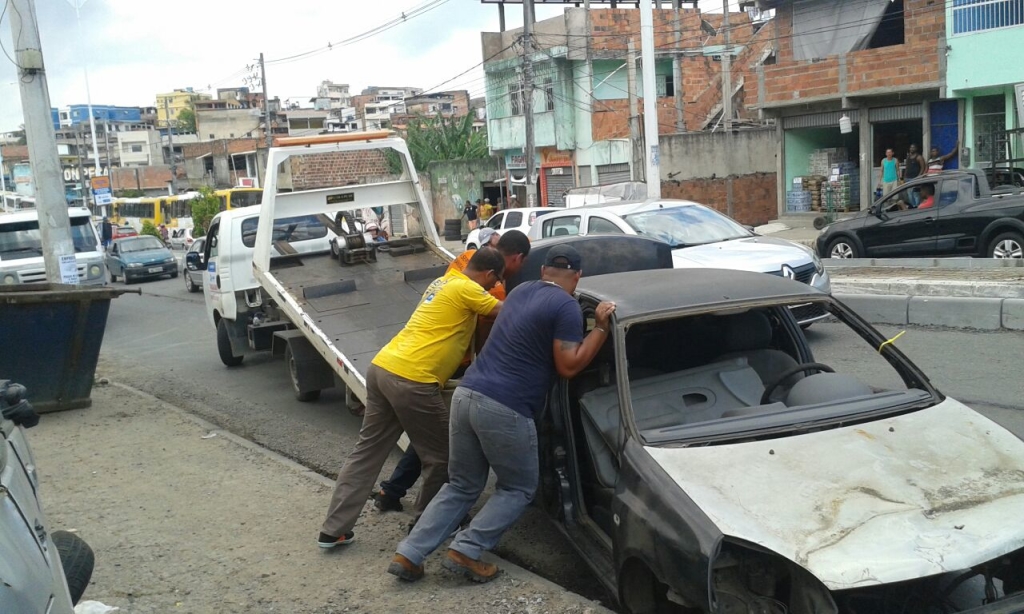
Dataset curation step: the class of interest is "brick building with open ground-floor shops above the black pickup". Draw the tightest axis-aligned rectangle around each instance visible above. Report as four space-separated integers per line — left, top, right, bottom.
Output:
748 0 950 213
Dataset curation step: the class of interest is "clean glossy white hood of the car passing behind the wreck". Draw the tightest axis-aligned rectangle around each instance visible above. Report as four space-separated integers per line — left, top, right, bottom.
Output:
672 236 811 273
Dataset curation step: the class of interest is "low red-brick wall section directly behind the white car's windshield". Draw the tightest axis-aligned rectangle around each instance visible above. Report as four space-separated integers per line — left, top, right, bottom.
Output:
662 173 778 226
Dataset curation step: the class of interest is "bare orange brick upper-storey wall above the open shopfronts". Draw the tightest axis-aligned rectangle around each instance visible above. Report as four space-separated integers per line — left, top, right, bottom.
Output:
748 0 945 103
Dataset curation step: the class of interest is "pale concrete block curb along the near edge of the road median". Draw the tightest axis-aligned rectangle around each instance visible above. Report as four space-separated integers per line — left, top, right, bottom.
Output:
835 294 1024 331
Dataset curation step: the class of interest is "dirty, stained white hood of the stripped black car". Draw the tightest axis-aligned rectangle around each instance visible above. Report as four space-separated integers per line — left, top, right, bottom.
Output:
646 399 1024 590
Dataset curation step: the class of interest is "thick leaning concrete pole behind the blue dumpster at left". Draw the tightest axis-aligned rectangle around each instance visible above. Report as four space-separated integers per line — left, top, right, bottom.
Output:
8 0 78 283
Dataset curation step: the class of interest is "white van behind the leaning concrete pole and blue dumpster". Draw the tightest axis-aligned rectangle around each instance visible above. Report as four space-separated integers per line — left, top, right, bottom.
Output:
0 207 106 286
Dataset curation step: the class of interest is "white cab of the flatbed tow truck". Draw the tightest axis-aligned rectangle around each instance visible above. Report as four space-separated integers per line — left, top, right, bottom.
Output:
185 207 335 365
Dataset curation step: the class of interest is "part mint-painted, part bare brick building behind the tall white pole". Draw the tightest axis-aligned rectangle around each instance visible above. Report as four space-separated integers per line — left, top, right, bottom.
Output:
482 8 772 205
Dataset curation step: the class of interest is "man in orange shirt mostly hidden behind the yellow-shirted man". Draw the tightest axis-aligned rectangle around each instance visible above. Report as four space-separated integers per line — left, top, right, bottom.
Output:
371 228 529 513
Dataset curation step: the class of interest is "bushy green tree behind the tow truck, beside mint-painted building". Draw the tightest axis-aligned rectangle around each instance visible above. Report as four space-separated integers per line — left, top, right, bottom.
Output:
406 113 489 169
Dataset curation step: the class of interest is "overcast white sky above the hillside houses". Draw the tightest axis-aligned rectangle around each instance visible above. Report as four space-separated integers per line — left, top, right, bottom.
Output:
0 0 721 132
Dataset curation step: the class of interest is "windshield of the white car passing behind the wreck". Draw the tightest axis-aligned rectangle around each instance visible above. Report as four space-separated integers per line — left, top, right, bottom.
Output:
624 205 753 248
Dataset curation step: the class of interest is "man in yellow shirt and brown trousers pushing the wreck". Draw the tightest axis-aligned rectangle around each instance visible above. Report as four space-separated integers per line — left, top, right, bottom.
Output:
317 249 505 549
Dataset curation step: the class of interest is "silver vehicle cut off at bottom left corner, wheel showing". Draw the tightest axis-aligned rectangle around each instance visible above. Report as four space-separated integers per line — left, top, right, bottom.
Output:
0 380 94 614
